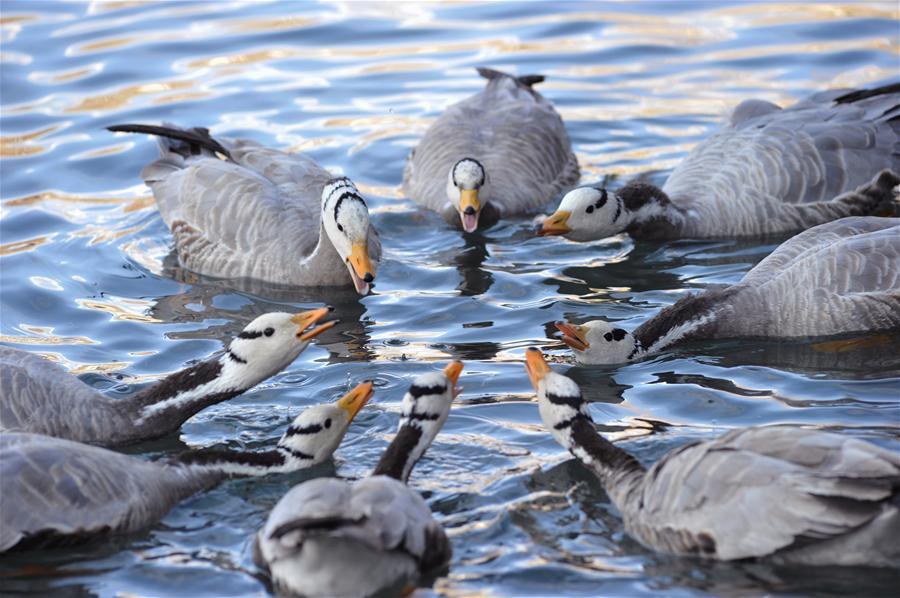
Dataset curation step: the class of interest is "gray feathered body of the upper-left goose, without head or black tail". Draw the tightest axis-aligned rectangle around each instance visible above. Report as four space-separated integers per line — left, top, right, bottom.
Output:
142 132 346 284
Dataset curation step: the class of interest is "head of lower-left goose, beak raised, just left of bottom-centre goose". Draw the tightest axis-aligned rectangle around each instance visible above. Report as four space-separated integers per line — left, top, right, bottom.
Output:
278 381 372 466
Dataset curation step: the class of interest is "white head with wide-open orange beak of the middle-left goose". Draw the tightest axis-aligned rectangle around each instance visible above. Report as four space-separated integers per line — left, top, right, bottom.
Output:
221 307 337 388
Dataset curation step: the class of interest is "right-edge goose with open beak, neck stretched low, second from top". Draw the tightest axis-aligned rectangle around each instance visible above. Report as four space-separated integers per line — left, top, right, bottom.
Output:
556 216 900 364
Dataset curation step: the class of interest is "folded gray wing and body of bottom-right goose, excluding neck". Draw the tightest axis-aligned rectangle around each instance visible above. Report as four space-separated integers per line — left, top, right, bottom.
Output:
626 426 900 560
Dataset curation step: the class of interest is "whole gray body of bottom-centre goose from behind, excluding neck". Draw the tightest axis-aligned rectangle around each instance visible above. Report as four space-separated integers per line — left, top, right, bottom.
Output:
254 476 451 596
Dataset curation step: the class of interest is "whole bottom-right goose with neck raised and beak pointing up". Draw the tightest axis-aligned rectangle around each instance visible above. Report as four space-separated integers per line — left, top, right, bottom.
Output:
526 348 900 567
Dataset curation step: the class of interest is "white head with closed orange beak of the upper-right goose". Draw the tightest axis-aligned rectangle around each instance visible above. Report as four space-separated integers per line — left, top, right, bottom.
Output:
538 187 631 241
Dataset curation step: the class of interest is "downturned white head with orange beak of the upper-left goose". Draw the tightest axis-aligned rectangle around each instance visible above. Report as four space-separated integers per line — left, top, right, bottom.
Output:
322 177 375 295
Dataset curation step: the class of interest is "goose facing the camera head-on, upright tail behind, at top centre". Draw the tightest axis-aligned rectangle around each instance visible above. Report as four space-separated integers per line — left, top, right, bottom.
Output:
403 68 579 232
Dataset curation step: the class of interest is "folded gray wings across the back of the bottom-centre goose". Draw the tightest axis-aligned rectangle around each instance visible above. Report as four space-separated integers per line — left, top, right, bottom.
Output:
257 476 451 572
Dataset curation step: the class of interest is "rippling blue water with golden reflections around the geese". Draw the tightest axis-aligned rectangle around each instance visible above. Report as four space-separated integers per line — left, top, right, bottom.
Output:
0 2 900 596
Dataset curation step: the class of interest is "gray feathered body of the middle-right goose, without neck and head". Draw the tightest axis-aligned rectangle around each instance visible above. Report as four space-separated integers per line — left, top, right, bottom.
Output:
722 217 900 337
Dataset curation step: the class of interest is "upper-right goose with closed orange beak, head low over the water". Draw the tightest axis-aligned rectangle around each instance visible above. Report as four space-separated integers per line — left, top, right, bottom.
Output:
540 83 900 241
